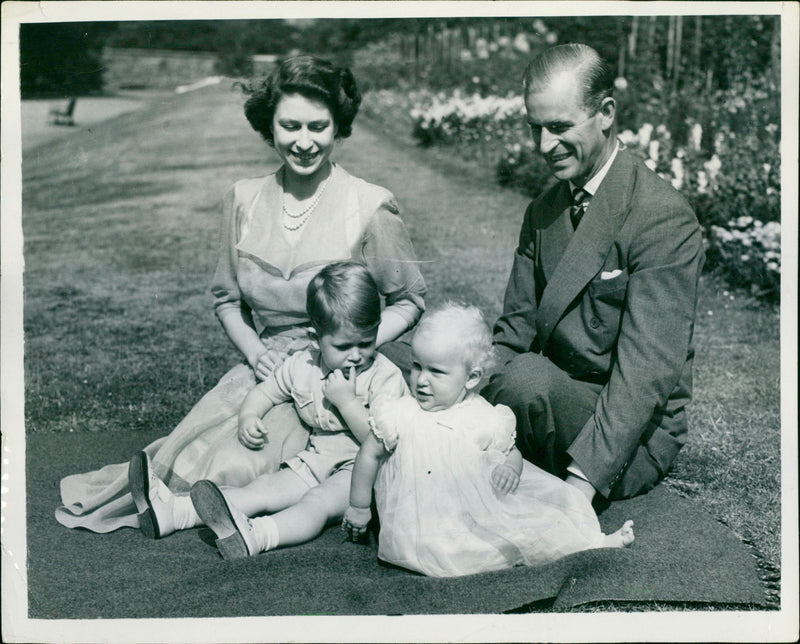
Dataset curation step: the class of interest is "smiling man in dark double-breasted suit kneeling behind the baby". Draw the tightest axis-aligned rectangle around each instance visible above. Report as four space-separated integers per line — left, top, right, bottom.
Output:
483 44 704 506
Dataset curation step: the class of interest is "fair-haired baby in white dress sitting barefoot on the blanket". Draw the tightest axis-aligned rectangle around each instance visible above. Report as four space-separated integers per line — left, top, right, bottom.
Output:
343 303 634 577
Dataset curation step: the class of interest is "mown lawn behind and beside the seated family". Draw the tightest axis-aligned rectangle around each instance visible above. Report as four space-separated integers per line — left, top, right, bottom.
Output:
23 85 780 584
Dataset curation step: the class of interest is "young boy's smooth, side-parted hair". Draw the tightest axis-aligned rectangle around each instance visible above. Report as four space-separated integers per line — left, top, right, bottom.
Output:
306 260 381 335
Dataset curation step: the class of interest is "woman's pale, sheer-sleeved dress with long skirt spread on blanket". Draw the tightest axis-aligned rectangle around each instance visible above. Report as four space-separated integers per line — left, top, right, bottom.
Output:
56 165 426 532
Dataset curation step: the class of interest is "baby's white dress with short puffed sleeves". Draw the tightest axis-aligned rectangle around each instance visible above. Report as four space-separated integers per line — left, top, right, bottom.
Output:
371 396 603 577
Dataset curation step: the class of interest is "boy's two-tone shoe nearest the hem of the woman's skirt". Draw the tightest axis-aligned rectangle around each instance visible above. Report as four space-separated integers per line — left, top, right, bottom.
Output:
128 452 175 539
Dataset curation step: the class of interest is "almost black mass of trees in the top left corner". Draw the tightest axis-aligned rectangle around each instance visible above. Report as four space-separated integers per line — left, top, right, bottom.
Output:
19 22 116 98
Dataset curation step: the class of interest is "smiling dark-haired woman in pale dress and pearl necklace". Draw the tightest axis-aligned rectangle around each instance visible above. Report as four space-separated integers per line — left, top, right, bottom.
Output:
56 56 426 533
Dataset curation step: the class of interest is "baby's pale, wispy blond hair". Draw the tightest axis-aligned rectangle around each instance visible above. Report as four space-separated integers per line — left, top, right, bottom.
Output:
414 301 495 373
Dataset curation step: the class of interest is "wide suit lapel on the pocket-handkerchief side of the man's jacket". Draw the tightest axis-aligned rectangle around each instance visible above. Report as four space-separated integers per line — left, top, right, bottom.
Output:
536 150 633 348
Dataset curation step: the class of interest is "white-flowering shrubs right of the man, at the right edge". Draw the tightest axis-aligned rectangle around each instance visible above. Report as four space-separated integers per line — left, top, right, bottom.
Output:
620 77 781 299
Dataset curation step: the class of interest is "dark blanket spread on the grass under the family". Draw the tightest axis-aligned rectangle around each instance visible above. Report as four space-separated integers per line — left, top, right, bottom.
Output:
27 432 765 619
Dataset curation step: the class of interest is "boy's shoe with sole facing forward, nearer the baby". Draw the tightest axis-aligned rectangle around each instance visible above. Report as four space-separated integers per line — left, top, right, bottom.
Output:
191 481 260 560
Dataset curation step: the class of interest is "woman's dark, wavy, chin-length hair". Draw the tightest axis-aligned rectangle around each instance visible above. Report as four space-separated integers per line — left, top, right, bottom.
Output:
243 55 361 145
